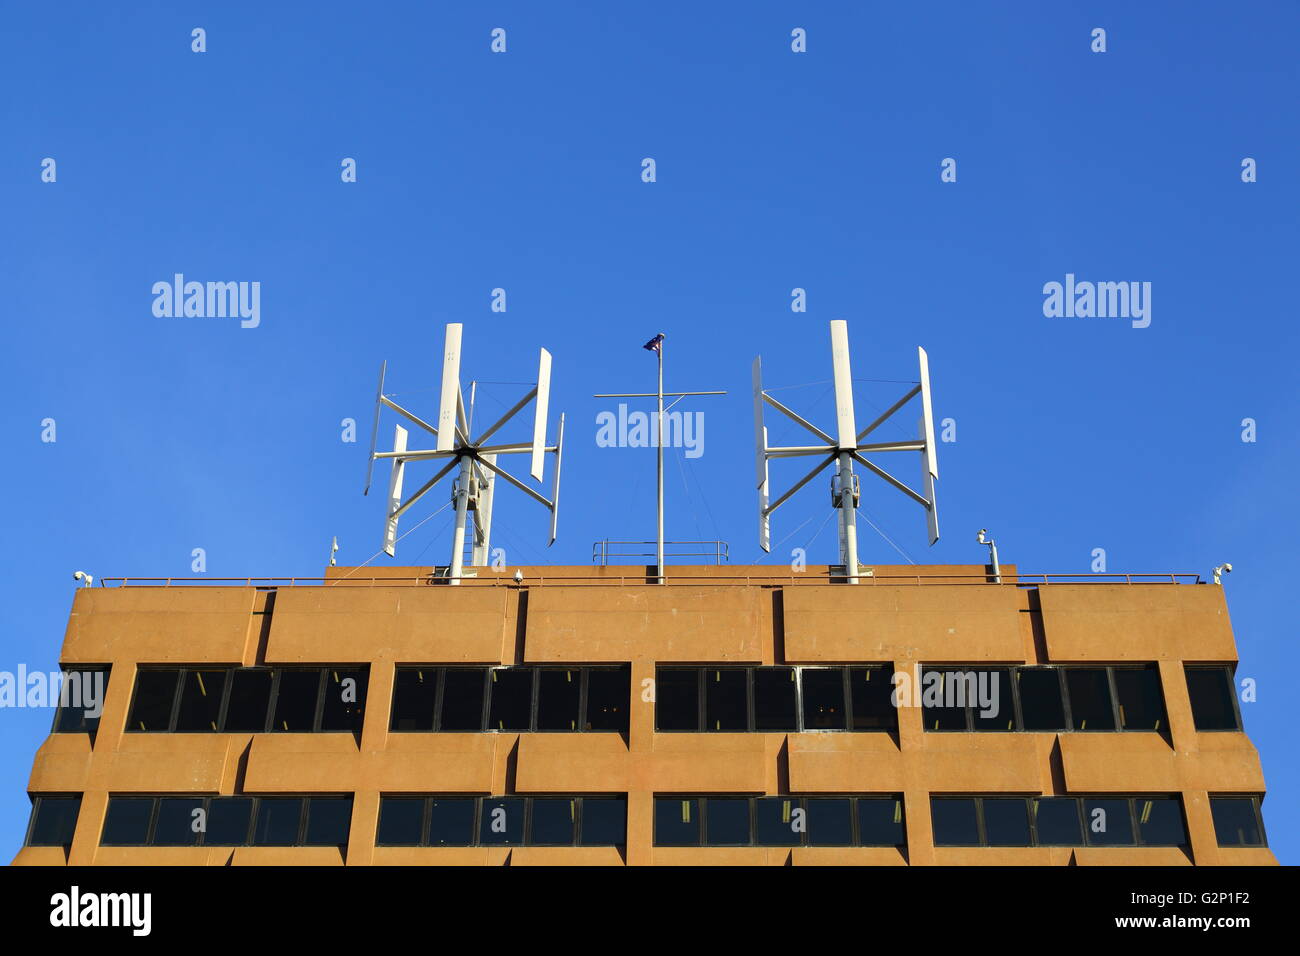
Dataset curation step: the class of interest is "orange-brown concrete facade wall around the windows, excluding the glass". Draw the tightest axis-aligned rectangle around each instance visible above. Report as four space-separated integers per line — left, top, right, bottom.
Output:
14 566 1275 865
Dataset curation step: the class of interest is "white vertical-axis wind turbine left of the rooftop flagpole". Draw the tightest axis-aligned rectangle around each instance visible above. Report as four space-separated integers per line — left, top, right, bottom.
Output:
363 323 564 584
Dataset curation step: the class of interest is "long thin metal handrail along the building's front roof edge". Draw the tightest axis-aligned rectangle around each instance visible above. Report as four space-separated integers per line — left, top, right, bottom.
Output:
99 571 1204 589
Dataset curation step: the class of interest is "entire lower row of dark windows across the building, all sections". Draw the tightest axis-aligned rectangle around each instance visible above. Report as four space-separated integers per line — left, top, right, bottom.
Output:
25 795 1268 848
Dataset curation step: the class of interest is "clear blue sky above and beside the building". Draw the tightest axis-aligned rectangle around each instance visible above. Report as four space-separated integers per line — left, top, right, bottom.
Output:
0 1 1300 862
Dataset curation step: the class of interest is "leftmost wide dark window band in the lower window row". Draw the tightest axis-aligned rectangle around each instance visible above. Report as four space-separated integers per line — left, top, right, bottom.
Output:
99 796 352 847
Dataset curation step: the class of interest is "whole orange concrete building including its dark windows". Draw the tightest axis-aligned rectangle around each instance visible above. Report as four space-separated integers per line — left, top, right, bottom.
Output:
14 566 1277 865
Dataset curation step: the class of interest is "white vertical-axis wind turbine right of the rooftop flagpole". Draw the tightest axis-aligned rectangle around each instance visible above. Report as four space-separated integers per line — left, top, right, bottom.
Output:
754 319 939 584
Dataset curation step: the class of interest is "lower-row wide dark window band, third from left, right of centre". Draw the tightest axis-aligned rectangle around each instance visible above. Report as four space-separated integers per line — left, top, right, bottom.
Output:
654 795 907 847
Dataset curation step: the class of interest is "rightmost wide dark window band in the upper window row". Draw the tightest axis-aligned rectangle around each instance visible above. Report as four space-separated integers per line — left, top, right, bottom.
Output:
919 665 1167 732
